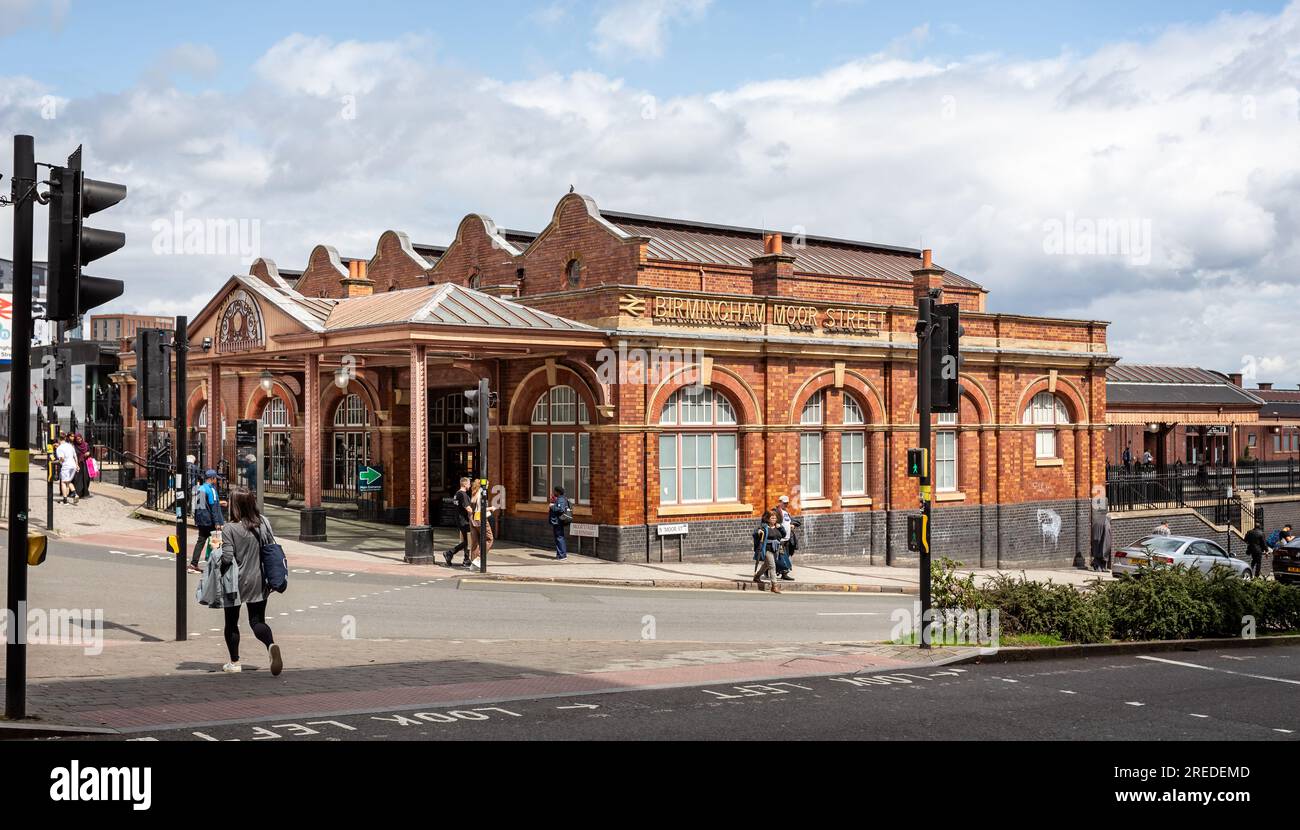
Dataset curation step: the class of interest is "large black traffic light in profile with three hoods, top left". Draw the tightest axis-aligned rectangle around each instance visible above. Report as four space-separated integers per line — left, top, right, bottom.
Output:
46 147 126 321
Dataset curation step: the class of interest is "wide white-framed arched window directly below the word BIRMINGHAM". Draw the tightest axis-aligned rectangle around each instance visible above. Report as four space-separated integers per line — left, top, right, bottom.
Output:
659 386 740 505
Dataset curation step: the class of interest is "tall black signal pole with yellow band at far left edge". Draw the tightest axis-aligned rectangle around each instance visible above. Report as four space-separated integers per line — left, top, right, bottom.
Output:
4 135 36 721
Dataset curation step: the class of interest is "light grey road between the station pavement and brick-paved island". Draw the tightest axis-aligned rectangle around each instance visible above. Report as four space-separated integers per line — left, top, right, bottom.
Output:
0 540 913 643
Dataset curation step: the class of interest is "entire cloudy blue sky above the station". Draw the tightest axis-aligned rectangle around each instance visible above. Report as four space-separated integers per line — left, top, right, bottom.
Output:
0 0 1300 386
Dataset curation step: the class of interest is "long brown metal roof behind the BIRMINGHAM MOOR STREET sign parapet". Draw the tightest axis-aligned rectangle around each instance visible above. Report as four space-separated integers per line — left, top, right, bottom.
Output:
601 211 980 289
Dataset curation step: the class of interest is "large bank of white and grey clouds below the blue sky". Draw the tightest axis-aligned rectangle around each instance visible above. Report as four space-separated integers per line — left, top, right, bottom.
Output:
0 0 1300 384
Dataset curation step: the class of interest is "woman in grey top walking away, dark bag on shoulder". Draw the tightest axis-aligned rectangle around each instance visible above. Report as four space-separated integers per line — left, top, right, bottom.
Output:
218 487 283 675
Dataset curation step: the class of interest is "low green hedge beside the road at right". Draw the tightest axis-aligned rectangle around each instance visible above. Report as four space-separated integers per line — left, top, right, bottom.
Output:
931 558 1300 643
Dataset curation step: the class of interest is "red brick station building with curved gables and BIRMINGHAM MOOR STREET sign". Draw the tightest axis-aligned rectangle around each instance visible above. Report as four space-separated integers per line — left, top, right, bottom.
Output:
116 193 1117 567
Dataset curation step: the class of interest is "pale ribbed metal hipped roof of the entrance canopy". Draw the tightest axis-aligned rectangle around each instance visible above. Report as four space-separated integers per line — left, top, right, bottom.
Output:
325 282 599 332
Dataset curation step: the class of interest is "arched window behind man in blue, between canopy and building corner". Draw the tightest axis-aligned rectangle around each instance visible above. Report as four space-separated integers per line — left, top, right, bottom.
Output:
529 386 592 503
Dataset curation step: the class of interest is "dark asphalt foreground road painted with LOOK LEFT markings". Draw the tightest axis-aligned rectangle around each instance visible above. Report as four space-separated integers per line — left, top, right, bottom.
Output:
78 647 1300 743
